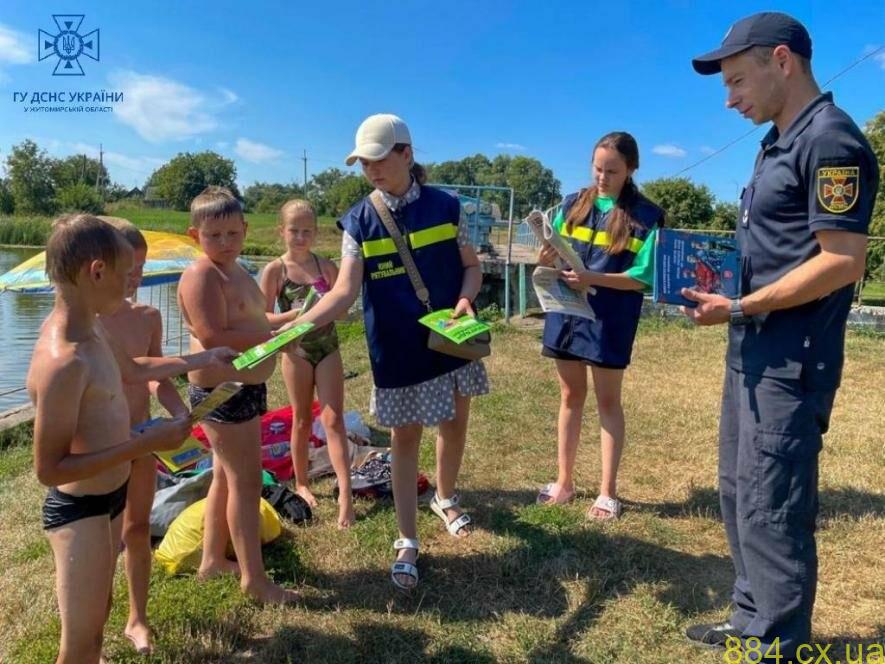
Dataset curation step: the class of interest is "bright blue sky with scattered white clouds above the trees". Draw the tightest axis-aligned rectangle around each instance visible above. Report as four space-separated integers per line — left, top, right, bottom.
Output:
0 0 885 205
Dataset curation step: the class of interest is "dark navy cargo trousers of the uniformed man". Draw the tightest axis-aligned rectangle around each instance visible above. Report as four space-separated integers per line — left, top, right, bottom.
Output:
719 367 836 656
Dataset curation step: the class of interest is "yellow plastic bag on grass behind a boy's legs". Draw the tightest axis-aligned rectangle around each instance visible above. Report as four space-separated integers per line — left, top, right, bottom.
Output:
154 498 282 574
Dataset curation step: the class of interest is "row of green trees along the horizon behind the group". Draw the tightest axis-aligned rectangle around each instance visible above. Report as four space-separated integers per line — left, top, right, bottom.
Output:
0 111 885 278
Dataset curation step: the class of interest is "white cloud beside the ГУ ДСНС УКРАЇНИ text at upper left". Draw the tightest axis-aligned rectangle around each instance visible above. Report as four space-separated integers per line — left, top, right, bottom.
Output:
110 71 237 143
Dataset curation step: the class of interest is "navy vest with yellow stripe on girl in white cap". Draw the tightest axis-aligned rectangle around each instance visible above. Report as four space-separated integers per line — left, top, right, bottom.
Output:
338 186 468 388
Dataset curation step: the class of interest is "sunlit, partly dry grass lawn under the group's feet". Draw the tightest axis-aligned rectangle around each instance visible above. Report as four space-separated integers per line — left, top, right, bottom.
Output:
0 321 885 664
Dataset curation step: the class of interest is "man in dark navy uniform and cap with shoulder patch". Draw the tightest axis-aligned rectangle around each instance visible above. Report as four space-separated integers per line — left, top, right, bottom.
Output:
683 12 879 661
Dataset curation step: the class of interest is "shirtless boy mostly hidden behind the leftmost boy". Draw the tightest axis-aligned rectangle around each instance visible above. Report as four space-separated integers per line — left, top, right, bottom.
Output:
99 217 188 655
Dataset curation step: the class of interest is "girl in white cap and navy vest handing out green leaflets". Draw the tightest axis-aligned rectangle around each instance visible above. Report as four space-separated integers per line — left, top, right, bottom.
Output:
282 114 489 589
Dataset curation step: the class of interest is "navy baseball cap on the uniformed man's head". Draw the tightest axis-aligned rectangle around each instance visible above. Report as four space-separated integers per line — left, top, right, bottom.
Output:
691 12 811 75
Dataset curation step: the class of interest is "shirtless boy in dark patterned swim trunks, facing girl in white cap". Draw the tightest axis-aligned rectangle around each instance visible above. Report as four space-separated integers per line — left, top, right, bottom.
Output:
178 187 296 603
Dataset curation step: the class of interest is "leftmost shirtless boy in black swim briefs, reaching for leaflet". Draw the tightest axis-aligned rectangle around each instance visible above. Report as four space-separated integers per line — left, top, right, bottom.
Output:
27 215 234 663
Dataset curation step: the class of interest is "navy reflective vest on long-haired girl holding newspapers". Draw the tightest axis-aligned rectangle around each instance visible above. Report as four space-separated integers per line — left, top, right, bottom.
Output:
543 193 664 367
